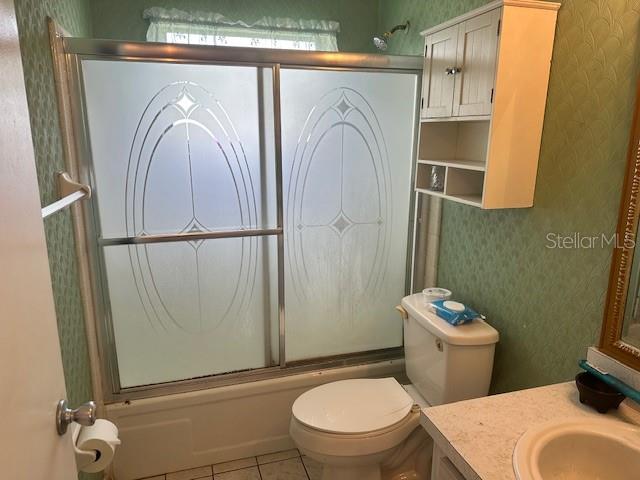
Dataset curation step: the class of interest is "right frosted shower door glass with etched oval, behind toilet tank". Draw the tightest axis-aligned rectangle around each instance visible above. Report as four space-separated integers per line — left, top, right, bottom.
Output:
281 69 417 360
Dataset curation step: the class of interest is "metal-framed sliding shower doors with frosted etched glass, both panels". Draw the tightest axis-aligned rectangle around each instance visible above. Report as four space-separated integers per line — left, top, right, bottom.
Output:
64 38 420 400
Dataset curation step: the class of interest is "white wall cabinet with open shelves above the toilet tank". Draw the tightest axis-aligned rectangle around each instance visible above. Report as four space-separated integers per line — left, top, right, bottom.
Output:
416 0 560 209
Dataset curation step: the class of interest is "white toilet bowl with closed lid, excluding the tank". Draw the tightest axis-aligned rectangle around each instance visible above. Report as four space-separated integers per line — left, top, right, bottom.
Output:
289 378 431 480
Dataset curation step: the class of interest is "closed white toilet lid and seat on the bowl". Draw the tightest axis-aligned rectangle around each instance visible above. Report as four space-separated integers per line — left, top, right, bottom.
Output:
292 378 414 435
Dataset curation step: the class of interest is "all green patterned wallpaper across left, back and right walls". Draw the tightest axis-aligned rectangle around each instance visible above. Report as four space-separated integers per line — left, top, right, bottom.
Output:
16 0 640 436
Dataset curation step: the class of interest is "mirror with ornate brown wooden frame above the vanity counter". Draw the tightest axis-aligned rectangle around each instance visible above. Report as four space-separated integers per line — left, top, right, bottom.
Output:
600 79 640 370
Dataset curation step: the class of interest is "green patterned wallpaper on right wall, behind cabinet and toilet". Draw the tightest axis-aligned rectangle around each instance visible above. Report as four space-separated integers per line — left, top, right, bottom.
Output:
380 0 640 392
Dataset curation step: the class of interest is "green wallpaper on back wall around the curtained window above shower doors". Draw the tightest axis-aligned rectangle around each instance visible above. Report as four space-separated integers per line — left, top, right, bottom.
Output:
91 0 378 52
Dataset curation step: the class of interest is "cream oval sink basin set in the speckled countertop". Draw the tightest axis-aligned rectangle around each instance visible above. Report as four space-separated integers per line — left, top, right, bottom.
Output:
513 417 640 480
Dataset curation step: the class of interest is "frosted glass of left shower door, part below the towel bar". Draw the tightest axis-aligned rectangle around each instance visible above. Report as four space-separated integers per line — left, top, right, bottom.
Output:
104 237 278 387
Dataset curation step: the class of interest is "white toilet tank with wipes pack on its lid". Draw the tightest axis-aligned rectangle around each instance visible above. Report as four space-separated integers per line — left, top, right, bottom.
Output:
402 293 498 405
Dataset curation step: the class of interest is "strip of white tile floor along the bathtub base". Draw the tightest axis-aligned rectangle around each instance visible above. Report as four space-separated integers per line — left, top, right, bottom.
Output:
138 449 322 480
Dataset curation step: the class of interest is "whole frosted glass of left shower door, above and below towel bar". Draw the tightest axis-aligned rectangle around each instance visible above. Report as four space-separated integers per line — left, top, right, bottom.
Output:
82 60 279 387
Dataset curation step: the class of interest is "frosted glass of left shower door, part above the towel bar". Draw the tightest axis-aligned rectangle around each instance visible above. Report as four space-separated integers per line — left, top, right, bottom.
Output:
82 60 276 237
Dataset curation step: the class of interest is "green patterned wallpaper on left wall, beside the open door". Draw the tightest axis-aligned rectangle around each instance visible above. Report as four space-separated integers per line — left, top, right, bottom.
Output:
15 0 92 450
